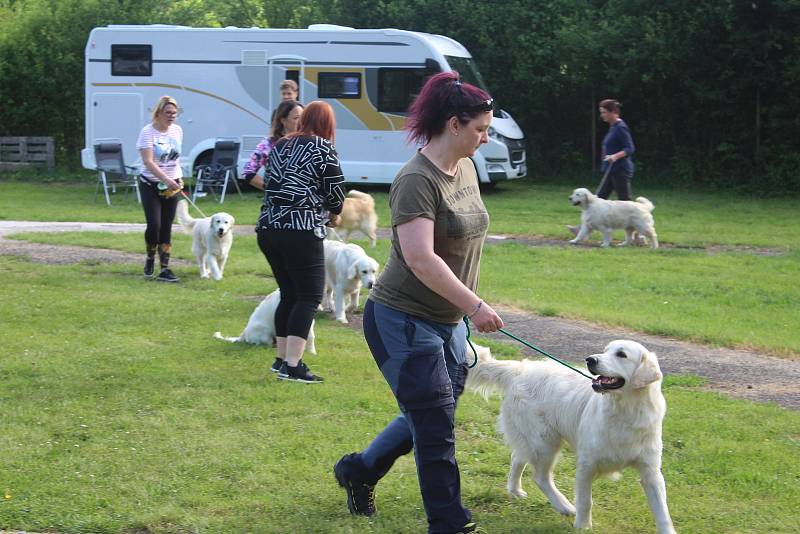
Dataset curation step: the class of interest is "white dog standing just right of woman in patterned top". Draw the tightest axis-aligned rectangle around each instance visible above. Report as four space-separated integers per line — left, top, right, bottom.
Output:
322 239 380 324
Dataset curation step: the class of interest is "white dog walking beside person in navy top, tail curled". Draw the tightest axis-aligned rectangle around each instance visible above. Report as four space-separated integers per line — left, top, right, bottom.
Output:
569 187 658 248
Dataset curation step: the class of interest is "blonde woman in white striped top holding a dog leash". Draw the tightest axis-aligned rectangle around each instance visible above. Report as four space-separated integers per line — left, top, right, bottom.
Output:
136 96 183 282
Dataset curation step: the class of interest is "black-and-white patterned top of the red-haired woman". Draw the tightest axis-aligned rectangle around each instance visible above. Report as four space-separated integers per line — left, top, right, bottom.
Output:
256 136 345 238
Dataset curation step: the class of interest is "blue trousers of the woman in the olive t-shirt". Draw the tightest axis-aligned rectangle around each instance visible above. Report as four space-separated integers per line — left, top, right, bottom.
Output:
359 299 472 533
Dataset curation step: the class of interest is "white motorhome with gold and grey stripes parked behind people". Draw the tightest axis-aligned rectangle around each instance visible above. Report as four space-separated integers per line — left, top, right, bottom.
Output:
81 25 527 183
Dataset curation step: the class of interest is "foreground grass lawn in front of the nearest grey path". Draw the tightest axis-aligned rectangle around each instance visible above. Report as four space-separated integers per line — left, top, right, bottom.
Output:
0 258 800 533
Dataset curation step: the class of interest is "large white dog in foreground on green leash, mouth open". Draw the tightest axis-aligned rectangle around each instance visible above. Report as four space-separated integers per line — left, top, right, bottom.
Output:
467 340 675 534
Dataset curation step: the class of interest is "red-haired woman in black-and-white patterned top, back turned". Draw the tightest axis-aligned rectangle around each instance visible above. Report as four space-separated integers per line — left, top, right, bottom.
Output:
256 101 345 384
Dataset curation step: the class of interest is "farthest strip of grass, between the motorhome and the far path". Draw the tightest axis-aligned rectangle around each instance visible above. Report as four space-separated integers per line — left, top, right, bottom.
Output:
0 180 800 250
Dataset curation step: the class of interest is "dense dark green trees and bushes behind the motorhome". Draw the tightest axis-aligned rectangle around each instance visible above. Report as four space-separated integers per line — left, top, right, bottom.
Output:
0 0 800 192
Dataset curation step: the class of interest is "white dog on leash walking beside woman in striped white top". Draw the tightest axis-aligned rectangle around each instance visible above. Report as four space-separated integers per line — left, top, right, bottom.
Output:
178 200 235 280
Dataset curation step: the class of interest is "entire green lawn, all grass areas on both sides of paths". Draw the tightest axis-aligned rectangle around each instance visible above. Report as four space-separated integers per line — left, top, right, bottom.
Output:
0 177 800 534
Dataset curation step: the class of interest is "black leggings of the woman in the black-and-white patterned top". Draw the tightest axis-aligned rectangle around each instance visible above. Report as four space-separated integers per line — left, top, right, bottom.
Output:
258 229 325 339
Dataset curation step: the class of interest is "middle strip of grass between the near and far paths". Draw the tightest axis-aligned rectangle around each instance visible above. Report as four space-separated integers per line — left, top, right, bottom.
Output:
10 232 800 358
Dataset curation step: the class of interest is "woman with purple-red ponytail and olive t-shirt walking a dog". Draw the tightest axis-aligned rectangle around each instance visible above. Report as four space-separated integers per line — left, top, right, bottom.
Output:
334 72 503 533
